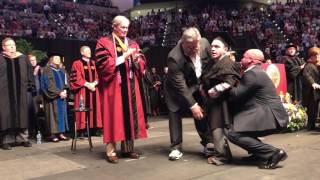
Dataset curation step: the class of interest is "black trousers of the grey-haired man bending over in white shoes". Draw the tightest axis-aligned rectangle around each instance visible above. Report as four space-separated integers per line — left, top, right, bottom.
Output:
169 110 212 150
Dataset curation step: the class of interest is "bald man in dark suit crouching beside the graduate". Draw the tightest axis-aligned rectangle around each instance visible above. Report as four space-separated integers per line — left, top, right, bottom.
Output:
228 49 288 169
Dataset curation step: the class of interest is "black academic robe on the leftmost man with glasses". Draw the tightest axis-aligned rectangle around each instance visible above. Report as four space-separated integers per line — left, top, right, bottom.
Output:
0 54 34 143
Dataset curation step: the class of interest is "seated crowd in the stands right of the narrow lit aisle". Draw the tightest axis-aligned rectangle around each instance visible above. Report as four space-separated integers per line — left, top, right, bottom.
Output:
169 2 320 62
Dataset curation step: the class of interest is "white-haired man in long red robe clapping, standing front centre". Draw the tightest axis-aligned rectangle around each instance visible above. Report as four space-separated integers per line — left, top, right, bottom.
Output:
96 16 147 163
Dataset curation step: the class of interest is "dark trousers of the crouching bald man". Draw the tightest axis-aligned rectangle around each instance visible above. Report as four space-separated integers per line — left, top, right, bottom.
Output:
228 129 278 160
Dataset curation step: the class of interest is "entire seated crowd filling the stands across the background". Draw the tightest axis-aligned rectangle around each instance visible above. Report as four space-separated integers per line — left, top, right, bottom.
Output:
0 0 320 57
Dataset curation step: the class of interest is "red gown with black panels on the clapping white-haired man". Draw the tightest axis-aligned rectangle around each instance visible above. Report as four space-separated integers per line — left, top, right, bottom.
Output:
96 36 147 143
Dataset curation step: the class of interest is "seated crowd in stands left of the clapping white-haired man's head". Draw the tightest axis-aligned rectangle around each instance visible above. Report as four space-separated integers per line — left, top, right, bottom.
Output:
0 1 118 40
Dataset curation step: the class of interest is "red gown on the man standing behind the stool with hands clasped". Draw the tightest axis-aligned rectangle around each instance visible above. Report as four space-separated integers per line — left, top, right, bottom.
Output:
70 60 102 129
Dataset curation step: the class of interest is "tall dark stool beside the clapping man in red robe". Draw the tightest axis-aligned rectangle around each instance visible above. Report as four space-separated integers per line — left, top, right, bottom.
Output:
70 108 93 153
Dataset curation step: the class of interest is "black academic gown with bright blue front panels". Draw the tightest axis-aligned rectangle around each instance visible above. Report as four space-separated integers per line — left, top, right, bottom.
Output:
40 65 69 135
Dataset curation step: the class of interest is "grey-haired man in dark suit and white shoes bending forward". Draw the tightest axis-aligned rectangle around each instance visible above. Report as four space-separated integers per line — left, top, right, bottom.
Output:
164 27 211 160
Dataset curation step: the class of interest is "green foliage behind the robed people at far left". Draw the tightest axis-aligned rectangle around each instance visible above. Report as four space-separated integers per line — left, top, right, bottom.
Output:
16 39 48 62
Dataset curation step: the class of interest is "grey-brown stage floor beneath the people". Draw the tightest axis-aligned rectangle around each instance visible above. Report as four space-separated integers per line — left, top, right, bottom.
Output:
0 116 320 180
